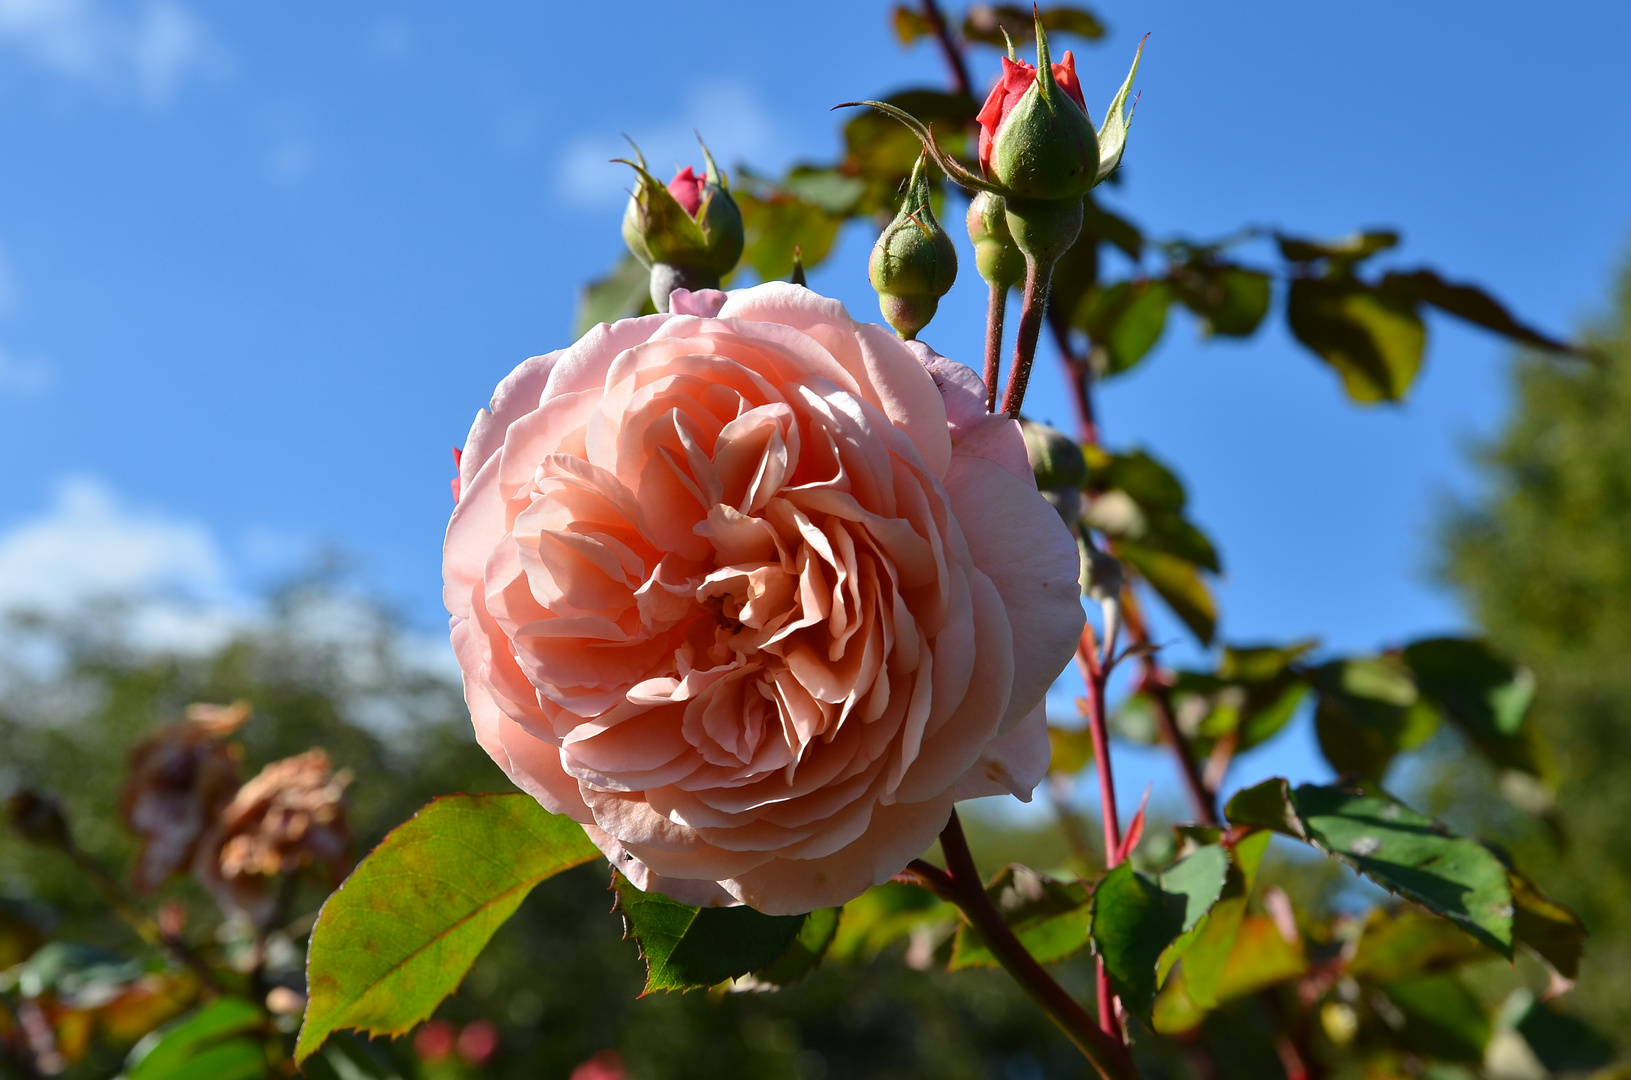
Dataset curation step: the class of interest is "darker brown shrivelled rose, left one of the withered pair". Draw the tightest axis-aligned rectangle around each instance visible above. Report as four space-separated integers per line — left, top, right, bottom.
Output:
119 702 250 892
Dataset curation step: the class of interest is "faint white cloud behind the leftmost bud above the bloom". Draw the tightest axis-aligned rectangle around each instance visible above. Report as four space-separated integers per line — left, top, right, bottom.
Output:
559 82 788 206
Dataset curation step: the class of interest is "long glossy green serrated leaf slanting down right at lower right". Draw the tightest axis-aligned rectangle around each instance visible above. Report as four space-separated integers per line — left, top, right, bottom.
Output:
1225 778 1514 958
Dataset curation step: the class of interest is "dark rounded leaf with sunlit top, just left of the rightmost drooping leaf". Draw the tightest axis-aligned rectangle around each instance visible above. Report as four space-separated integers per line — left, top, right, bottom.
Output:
1313 656 1439 783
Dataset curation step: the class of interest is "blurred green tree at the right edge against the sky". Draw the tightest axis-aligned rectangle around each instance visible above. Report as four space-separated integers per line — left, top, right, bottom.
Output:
1439 251 1631 1047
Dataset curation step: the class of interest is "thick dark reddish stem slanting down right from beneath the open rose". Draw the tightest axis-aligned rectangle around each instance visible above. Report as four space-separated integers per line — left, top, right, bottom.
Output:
907 811 1138 1080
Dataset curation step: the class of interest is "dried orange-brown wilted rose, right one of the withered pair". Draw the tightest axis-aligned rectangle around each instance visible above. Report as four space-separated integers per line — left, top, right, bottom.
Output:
197 749 351 918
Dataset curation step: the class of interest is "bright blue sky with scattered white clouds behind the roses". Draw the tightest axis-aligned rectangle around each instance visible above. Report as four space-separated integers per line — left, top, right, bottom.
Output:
0 0 1631 809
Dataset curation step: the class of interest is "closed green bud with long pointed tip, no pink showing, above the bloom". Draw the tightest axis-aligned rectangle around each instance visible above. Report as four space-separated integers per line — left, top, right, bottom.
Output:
868 153 957 341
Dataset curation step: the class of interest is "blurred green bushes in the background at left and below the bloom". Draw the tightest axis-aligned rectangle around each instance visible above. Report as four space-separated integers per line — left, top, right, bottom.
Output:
0 589 1091 1080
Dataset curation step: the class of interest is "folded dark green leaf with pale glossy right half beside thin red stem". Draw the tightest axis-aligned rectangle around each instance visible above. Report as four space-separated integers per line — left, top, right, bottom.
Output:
1093 845 1228 1021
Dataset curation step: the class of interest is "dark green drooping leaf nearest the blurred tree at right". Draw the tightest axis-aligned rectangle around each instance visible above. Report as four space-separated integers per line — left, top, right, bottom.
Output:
1404 638 1549 777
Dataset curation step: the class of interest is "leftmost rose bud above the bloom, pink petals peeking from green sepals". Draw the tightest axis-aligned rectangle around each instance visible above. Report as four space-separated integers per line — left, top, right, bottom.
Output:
618 140 744 312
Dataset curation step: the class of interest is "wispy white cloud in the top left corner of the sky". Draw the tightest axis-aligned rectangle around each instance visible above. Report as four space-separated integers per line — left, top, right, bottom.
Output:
0 0 222 104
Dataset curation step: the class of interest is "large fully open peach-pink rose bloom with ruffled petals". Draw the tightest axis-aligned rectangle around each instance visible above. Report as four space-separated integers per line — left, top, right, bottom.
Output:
444 282 1083 914
